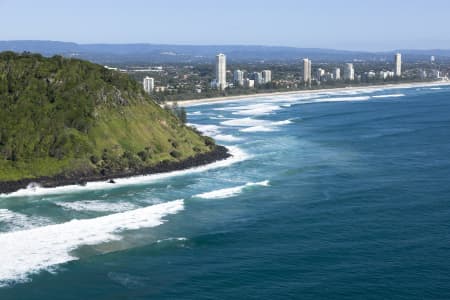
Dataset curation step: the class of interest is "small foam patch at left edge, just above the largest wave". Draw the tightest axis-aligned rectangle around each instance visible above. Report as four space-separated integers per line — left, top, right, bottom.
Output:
0 209 51 232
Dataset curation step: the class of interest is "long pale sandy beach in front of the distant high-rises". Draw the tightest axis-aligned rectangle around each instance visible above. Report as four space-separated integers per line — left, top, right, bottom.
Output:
166 81 450 107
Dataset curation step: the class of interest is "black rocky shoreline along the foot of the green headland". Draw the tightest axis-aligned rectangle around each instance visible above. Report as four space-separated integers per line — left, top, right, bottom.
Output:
0 145 232 195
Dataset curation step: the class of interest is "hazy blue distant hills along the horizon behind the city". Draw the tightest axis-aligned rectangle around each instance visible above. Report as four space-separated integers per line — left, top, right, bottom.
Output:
0 41 450 64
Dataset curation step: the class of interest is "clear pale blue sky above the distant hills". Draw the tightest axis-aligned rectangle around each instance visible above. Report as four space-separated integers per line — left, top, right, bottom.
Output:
0 0 450 51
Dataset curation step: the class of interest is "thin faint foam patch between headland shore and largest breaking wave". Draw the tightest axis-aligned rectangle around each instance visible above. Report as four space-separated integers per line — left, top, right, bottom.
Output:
55 200 138 212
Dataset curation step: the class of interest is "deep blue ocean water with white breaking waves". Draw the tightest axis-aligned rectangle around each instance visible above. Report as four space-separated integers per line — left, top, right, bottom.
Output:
0 86 450 300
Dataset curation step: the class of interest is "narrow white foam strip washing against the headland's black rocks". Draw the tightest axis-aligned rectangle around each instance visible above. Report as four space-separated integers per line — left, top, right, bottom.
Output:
0 146 250 198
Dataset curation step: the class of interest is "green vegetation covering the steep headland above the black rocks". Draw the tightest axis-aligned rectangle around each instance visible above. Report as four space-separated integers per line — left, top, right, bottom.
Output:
0 52 215 181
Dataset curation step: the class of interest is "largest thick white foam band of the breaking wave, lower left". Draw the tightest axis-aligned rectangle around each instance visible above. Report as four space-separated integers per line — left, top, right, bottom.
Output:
0 200 184 286
